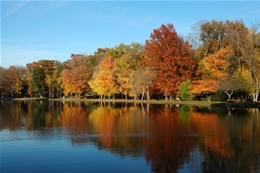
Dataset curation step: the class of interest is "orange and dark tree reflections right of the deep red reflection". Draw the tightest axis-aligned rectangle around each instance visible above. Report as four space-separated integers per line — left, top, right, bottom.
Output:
192 109 260 173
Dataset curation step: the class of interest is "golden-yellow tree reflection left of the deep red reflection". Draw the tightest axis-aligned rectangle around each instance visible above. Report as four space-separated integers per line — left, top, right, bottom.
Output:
89 106 147 157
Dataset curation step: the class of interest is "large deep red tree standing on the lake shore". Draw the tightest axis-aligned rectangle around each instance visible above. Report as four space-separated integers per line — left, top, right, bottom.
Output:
144 24 195 98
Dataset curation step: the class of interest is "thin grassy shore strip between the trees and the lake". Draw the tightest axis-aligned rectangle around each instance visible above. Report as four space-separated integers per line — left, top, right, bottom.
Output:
0 97 260 109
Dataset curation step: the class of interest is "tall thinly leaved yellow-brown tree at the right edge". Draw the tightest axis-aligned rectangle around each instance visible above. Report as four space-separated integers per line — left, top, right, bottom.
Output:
224 21 260 101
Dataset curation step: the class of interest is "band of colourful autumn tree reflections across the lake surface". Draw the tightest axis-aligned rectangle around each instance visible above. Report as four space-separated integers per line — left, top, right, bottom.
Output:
0 101 260 172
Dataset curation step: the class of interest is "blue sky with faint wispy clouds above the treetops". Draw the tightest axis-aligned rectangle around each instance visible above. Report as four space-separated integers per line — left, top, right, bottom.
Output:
0 0 260 68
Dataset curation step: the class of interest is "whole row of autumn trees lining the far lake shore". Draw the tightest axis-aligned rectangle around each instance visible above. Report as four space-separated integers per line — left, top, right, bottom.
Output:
0 20 260 102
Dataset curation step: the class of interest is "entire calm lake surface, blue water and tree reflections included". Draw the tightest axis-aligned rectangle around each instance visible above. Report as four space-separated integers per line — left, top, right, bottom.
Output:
0 101 260 173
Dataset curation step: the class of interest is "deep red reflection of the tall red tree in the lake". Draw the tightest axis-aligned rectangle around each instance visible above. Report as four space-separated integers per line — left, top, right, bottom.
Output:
146 107 196 172
